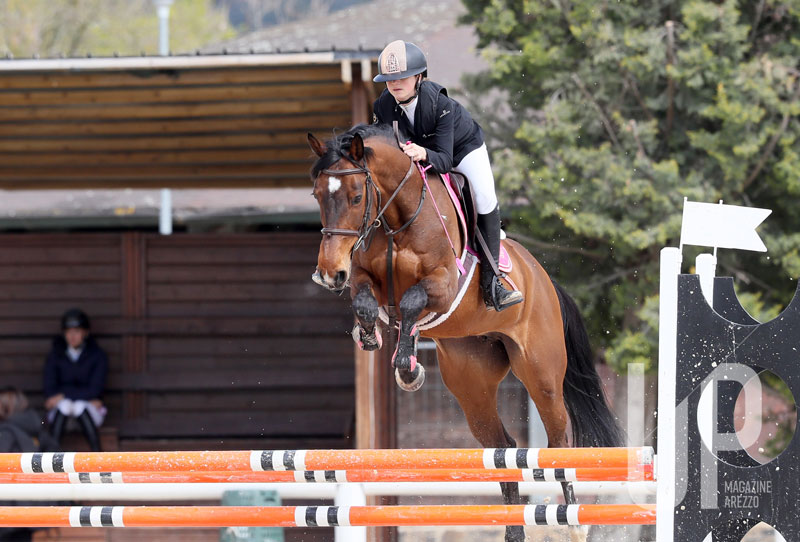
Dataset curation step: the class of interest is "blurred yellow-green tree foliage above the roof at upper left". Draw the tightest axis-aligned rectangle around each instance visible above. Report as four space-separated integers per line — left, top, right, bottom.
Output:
0 0 235 57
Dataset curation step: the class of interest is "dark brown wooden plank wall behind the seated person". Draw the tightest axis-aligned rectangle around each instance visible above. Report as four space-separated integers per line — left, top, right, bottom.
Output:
0 232 355 450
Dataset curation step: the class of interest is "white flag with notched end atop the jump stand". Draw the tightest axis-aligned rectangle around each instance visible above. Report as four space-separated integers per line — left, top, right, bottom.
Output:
681 198 772 252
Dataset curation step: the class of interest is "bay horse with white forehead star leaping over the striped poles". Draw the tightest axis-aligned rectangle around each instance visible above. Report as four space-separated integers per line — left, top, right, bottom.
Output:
308 125 622 542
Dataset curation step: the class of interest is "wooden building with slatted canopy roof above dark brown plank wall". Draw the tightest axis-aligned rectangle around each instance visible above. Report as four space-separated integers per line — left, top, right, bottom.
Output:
0 51 388 456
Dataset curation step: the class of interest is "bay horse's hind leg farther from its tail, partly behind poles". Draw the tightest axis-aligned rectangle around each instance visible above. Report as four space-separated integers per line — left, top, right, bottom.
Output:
436 337 525 542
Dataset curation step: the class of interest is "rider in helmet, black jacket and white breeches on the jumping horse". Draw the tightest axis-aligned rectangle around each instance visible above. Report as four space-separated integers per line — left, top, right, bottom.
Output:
373 40 523 311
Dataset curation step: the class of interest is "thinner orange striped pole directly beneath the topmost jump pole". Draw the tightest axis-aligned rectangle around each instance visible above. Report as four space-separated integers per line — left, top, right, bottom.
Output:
0 465 653 484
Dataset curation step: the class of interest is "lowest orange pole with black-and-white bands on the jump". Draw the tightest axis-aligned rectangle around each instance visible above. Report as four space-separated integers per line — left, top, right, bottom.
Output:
0 504 656 527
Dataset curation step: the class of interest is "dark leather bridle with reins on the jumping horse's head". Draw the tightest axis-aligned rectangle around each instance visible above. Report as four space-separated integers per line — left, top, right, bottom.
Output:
320 157 427 252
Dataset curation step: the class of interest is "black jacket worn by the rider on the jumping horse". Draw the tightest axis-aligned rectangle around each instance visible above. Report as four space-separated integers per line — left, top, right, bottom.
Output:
373 80 483 173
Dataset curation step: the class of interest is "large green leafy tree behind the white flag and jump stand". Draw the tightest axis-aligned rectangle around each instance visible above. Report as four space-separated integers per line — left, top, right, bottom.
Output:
464 0 800 370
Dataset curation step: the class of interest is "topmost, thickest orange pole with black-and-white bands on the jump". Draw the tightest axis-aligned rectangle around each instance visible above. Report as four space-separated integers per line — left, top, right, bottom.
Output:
0 447 653 473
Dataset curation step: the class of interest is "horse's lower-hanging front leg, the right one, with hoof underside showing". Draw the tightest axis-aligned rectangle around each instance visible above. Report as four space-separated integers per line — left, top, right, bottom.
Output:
392 284 428 391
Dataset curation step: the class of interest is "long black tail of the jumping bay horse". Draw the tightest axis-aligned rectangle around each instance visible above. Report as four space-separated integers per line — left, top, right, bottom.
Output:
553 281 624 447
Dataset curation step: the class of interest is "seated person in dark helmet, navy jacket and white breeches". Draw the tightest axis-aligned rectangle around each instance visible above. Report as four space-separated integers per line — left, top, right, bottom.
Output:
44 309 108 452
